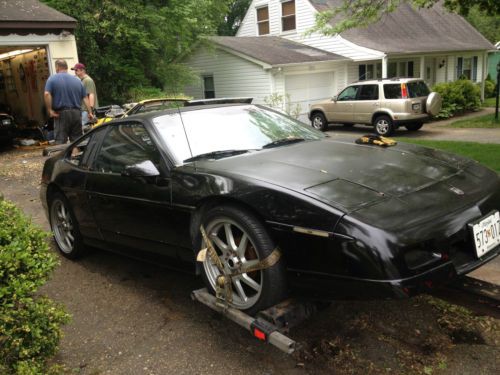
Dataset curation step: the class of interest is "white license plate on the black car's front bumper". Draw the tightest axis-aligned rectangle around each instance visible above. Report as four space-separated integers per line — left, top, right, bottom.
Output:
470 211 500 258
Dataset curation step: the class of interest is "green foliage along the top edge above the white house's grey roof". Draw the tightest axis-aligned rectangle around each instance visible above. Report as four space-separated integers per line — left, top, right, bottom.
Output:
310 0 500 35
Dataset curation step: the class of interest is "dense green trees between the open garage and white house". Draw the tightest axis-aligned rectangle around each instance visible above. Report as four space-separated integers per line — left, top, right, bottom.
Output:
43 0 231 103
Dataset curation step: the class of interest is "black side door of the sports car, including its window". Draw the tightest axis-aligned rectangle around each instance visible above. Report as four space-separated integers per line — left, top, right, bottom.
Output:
86 122 176 256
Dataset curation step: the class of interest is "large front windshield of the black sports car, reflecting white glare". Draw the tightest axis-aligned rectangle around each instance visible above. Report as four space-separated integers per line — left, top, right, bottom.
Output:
153 105 325 165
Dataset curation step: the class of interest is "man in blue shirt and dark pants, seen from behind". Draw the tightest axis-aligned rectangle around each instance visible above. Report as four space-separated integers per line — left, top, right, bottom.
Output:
44 60 93 144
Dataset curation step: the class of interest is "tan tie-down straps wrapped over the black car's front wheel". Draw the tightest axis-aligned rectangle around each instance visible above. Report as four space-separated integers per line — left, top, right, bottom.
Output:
196 226 281 306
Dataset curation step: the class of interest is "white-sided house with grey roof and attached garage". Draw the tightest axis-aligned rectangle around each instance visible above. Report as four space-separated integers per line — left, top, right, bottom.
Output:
184 0 494 119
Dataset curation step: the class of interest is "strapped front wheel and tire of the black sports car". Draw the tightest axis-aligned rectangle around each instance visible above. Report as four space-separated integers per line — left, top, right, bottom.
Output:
195 205 286 314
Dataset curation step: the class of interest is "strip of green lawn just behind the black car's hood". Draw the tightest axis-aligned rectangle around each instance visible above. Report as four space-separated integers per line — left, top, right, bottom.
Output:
398 138 500 173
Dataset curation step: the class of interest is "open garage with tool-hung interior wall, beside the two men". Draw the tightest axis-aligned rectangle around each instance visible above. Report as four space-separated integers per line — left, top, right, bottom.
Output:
0 0 78 125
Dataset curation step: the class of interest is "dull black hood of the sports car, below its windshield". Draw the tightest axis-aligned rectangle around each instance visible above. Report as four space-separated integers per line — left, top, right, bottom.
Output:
197 140 485 212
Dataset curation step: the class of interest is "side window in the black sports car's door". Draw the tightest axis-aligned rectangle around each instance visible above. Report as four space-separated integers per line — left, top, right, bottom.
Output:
93 123 161 173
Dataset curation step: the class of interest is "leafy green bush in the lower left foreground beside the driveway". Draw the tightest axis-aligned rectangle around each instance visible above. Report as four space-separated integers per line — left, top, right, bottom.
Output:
0 197 69 375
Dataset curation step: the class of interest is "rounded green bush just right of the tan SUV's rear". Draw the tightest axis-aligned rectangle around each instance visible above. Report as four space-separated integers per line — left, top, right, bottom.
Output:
433 79 481 118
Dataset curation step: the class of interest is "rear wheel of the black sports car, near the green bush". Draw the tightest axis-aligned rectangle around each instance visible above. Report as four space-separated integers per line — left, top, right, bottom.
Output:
49 192 86 259
